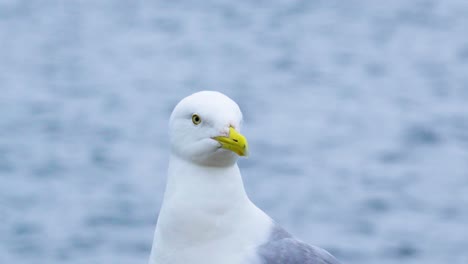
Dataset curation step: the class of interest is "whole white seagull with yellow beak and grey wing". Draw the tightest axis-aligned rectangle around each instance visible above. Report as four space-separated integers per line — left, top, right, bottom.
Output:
149 91 339 264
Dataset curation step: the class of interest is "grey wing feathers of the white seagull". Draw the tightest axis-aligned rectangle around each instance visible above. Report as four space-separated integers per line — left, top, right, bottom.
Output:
258 227 340 264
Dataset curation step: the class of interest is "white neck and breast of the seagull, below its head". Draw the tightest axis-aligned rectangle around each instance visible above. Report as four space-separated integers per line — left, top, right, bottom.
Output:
150 155 271 264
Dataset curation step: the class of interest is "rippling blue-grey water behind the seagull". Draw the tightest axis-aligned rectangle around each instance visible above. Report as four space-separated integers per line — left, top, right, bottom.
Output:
0 0 468 264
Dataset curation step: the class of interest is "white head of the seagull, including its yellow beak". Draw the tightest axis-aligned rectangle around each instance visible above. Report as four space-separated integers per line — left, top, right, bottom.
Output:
169 91 248 167
